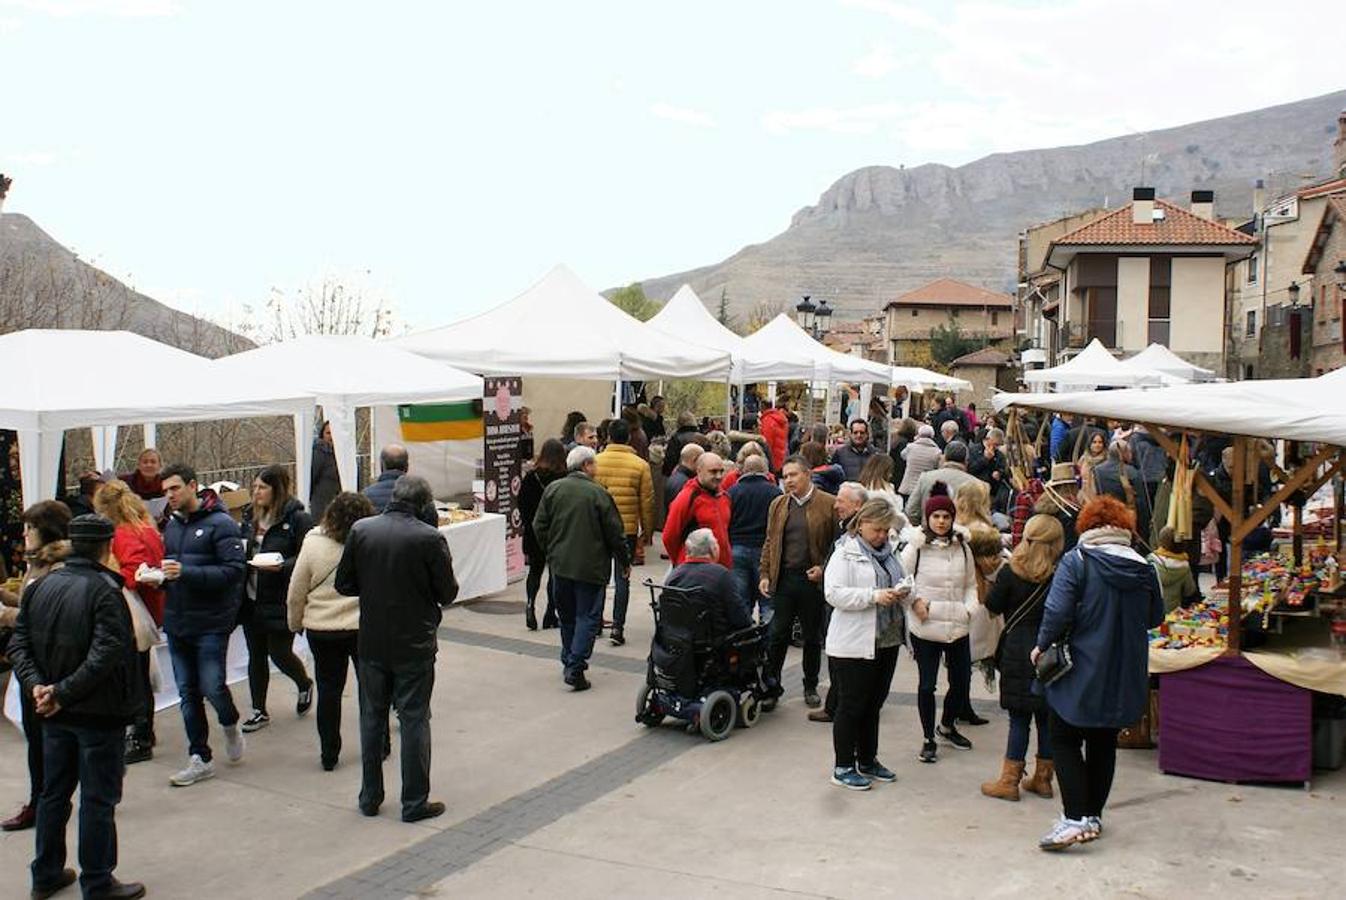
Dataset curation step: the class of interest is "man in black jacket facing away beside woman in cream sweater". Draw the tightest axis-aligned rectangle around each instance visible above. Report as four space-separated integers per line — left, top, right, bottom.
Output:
337 475 458 822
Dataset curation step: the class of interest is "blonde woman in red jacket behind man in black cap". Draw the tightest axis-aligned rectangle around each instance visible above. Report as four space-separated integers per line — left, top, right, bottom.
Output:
93 479 164 765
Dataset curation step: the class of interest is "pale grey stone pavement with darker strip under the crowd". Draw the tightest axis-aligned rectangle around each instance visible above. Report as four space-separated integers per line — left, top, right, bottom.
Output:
0 554 1346 900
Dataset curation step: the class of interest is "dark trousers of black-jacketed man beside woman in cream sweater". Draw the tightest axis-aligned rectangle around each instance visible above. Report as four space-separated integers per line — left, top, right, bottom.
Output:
359 659 435 817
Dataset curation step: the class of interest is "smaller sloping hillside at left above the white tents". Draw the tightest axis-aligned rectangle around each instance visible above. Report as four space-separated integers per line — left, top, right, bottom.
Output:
0 213 253 358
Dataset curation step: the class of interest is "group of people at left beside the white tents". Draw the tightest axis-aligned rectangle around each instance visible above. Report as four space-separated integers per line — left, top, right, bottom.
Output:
0 429 458 899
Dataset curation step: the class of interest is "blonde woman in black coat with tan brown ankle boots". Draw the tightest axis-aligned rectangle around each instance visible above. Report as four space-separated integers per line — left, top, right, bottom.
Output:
981 515 1066 800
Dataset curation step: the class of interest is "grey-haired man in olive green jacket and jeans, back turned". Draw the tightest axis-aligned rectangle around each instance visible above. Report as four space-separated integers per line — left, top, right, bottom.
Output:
533 447 631 690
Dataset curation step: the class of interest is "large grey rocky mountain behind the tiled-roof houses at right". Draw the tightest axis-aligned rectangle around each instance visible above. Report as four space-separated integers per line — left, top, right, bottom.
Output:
629 90 1346 319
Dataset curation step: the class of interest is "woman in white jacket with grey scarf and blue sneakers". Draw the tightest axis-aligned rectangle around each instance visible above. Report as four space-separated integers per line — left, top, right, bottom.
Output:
822 498 910 791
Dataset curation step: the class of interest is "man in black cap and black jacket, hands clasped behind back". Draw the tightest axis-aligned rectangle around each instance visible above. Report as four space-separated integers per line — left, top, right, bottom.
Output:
9 515 145 899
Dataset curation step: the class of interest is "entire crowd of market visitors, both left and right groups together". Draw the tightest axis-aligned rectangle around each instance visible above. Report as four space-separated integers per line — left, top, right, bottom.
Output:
0 397 1238 897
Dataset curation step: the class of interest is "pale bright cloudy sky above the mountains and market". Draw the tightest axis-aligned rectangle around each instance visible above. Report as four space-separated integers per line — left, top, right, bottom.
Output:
0 0 1346 328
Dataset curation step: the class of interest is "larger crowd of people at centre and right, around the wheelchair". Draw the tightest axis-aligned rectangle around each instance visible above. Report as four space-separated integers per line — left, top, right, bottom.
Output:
525 397 1184 849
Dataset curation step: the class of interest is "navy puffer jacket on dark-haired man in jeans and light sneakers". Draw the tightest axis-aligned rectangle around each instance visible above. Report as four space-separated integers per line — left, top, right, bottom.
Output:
164 490 248 638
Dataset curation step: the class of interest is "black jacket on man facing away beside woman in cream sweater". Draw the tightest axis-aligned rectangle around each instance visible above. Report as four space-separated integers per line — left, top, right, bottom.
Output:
337 500 458 665
